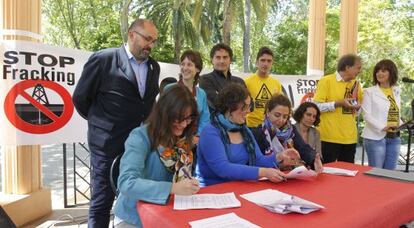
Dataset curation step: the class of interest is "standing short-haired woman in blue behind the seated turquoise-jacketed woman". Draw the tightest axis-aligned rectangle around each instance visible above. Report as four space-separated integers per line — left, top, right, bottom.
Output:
166 50 210 139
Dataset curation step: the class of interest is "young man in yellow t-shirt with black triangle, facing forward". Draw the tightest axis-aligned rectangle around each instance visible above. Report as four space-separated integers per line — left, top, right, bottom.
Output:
245 47 282 128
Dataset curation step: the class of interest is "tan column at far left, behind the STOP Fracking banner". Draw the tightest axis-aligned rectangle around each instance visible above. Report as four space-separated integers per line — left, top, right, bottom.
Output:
0 0 51 226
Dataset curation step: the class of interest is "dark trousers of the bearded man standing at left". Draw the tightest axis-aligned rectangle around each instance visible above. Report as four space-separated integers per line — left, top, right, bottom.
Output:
88 151 115 228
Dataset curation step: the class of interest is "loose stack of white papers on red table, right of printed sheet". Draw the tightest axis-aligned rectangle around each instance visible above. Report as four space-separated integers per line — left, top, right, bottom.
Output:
240 189 325 214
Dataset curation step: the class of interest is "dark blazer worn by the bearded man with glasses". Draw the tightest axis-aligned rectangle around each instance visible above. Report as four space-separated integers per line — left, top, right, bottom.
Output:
72 46 160 156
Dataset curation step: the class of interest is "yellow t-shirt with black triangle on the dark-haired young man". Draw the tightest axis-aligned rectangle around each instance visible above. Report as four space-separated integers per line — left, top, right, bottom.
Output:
245 74 282 127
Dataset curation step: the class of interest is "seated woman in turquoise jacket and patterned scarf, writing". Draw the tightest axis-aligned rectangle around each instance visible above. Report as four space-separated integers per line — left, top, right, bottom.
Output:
114 85 200 228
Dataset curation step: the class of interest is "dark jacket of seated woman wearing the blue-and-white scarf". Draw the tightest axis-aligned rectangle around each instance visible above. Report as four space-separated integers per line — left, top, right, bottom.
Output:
251 125 316 167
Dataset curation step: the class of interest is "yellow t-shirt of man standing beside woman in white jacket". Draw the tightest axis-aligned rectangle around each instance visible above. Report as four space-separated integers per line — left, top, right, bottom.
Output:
313 74 362 144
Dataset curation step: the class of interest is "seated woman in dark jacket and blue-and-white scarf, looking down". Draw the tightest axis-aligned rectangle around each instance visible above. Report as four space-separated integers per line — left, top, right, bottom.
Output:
253 94 322 172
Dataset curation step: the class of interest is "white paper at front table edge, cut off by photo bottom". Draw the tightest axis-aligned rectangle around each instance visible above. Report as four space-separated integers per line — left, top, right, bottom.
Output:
189 213 259 228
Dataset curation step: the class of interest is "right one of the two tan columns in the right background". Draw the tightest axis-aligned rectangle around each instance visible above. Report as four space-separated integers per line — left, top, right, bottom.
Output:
339 0 359 56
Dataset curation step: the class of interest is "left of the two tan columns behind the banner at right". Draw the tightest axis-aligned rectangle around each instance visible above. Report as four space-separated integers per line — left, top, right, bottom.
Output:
306 0 326 76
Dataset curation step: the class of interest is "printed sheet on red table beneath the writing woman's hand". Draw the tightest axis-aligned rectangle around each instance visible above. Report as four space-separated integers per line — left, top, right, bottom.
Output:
174 192 241 210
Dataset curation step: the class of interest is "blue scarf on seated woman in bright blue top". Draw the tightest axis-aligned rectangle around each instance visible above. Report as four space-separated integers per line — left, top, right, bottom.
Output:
211 113 256 166
